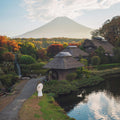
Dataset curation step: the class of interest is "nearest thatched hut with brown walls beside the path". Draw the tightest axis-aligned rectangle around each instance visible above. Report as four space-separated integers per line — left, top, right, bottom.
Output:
43 52 84 80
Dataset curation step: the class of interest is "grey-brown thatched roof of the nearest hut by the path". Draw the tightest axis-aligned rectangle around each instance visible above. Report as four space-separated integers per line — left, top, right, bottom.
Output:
43 52 84 69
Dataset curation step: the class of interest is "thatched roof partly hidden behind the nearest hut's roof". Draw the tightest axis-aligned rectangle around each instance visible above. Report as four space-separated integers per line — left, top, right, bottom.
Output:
62 46 89 57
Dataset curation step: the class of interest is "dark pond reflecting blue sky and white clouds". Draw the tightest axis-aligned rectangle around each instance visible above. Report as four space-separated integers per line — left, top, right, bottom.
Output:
57 76 120 120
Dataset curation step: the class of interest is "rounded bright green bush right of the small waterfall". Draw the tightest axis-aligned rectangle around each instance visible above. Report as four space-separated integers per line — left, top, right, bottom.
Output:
19 55 35 64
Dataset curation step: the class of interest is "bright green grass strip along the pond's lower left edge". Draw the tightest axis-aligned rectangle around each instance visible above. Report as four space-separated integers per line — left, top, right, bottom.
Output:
39 94 74 120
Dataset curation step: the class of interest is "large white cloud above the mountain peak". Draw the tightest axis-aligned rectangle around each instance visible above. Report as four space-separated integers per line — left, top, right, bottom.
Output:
24 0 120 21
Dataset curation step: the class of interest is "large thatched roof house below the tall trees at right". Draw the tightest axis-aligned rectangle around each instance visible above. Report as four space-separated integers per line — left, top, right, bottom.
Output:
83 38 114 55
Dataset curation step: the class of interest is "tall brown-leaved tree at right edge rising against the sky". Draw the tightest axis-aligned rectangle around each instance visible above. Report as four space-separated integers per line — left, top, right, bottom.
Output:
94 16 120 45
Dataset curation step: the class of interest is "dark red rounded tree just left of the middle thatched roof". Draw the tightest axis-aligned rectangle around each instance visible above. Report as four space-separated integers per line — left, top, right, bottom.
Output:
47 44 64 57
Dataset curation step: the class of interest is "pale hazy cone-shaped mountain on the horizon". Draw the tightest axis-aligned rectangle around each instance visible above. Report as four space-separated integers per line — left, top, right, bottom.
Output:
17 17 92 38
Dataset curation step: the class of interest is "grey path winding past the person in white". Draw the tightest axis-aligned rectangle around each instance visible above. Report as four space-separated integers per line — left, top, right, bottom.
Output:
0 77 45 120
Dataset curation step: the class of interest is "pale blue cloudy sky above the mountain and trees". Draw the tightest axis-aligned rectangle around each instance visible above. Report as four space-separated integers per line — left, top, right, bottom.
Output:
0 0 120 37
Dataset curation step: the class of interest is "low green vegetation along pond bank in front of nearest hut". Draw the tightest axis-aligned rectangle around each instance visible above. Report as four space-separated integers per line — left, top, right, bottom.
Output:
43 76 104 97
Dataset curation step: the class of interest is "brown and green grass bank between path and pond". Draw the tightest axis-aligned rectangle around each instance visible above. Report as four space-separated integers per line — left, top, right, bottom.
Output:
19 94 75 120
